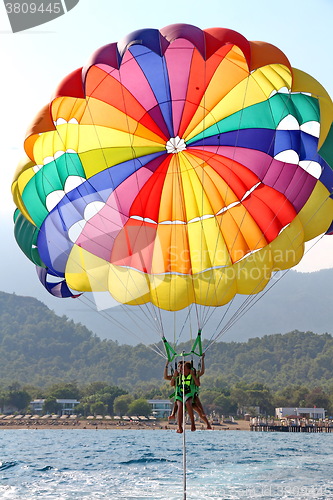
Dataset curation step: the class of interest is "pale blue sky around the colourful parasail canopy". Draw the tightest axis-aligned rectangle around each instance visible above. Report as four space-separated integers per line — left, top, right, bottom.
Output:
0 0 333 308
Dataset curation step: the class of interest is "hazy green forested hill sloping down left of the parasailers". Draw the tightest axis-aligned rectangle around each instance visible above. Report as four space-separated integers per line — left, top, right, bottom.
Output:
0 292 163 386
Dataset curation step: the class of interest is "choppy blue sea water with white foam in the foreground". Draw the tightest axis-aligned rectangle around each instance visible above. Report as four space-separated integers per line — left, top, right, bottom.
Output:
0 429 333 500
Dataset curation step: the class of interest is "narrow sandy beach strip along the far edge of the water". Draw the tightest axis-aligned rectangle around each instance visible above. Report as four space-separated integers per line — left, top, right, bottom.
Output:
0 419 250 431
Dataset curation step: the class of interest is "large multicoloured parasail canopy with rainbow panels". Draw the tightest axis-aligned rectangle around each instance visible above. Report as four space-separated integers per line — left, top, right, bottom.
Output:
12 24 333 310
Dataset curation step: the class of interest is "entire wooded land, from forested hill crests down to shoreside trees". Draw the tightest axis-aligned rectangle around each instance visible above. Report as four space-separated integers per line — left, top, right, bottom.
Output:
0 292 333 414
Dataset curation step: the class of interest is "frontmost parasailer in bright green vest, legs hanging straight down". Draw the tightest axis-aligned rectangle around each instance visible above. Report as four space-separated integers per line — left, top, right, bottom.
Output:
170 362 200 433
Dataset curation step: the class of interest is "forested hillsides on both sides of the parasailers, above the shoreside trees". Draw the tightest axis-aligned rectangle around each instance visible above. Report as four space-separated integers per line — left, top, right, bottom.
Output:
0 292 333 389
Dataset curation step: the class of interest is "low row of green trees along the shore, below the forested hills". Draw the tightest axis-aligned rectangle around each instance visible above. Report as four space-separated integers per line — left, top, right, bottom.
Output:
0 376 333 417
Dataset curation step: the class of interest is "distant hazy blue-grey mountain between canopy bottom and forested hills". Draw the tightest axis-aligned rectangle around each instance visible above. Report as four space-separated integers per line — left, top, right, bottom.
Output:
0 269 333 345
